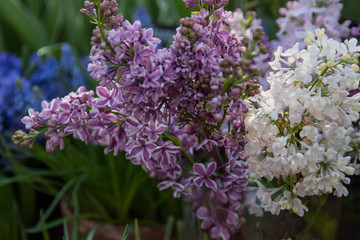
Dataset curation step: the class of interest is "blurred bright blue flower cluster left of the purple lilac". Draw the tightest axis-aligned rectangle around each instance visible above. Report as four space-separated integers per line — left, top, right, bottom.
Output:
0 43 87 135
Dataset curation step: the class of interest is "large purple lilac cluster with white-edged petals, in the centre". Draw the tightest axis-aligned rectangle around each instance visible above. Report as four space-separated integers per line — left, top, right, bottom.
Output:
13 0 259 239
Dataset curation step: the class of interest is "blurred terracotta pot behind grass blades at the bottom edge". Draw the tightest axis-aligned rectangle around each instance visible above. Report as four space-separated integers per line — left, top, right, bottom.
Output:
60 202 176 240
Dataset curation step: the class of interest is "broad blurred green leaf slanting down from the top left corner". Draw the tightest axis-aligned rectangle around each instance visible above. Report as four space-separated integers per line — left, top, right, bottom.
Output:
0 0 49 49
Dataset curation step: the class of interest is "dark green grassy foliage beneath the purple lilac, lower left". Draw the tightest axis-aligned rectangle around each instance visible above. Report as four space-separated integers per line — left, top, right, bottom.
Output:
0 138 180 239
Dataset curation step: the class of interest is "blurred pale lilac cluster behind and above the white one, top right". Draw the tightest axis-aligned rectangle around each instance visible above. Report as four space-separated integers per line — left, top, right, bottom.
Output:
274 0 351 50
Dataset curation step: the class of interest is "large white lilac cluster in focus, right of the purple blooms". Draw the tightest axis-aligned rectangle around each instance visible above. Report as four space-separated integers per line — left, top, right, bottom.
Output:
245 29 360 216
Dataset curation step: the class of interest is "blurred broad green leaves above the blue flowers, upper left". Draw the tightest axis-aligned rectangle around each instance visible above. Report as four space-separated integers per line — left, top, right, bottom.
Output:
0 0 91 55
